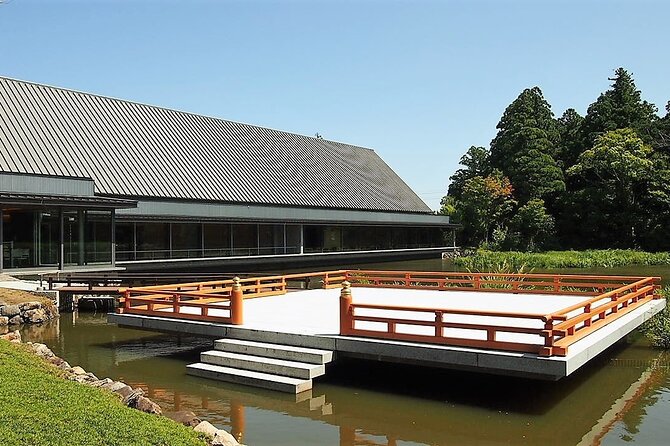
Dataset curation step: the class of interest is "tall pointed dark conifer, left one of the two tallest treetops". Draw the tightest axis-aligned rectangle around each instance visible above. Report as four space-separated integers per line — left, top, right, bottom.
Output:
491 87 565 203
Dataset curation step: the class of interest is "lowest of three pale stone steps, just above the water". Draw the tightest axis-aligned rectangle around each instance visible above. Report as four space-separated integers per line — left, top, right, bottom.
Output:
186 362 312 394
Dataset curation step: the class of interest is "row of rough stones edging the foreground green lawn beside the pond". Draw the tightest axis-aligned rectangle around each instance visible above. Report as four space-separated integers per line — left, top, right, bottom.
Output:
0 330 242 446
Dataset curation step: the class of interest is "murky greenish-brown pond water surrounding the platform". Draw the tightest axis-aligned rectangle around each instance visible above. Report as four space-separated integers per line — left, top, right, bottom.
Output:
18 260 670 446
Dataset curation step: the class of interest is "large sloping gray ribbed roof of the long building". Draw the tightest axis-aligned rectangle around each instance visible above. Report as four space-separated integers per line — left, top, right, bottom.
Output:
0 77 430 213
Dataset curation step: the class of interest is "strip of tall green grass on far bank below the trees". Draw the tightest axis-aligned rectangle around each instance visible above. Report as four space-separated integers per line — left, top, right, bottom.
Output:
454 249 670 271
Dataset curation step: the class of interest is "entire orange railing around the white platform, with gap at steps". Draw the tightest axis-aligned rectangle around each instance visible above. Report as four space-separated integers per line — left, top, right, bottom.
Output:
118 270 660 356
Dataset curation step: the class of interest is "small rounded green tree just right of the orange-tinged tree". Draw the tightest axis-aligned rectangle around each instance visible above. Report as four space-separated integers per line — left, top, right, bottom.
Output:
510 199 555 251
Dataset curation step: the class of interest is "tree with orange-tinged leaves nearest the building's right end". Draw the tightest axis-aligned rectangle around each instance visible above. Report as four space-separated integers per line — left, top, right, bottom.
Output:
454 171 515 245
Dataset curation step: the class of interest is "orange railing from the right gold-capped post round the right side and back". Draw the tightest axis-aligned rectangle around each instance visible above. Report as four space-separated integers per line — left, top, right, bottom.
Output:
340 271 660 356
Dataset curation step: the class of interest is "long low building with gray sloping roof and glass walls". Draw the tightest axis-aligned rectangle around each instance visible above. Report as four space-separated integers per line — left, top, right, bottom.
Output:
0 77 454 271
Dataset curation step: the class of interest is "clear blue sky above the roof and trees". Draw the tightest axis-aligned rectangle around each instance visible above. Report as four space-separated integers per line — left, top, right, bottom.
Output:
0 0 670 210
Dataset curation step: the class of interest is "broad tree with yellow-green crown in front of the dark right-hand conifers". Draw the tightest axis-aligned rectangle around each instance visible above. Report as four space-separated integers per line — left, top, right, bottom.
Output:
567 129 653 247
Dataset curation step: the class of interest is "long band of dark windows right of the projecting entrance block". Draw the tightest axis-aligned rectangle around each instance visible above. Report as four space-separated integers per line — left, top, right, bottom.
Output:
109 221 447 261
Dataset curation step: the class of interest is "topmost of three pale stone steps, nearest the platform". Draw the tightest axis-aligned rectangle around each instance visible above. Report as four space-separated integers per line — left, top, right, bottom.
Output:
214 339 333 364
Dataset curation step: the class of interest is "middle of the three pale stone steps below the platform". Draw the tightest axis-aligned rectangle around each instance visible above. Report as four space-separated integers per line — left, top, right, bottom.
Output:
200 350 326 379
